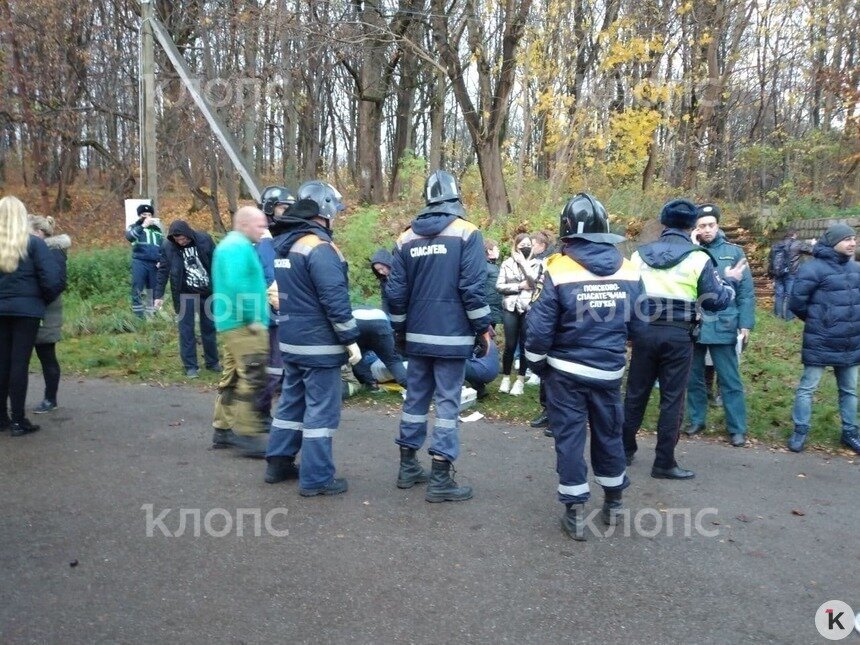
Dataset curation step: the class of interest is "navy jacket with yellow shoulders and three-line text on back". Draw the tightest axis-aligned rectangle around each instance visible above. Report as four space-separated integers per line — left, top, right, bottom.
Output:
526 239 647 387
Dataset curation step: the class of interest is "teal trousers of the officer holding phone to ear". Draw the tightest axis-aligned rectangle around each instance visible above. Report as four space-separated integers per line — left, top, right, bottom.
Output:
687 344 747 434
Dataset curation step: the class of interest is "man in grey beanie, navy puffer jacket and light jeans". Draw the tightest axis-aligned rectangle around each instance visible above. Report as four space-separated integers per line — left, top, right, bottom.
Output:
788 224 860 454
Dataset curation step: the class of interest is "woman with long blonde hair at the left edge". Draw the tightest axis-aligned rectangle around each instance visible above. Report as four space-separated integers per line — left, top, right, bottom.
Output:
0 196 65 437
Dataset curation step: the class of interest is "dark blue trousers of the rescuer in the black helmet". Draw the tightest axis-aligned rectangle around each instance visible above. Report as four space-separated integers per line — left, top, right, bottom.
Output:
541 368 630 504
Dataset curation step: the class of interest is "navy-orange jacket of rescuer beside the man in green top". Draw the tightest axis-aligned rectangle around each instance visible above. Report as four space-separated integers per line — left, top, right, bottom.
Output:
274 219 358 367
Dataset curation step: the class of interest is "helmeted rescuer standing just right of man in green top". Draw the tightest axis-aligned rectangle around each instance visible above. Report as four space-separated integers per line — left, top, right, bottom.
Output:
265 181 361 497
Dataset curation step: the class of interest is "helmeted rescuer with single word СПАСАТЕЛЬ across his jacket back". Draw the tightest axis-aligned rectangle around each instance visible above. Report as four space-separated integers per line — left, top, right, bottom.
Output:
385 170 492 502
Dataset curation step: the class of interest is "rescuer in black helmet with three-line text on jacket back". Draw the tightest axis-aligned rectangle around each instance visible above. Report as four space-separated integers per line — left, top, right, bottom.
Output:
526 193 645 540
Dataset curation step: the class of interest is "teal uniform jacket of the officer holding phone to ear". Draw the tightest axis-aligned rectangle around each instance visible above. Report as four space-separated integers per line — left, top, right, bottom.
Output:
697 231 755 345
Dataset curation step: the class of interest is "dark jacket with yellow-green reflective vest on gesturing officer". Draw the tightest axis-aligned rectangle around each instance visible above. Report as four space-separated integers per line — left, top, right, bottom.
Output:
632 228 735 323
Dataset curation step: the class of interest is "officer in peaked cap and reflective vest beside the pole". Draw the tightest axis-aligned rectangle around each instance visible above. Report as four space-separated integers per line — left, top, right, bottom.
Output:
125 204 164 318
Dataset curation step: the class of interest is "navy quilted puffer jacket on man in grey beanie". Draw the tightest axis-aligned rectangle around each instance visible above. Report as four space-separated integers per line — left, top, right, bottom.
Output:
788 244 860 367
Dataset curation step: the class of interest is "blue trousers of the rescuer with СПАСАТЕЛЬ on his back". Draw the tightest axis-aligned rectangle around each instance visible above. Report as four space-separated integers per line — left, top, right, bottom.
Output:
396 356 466 461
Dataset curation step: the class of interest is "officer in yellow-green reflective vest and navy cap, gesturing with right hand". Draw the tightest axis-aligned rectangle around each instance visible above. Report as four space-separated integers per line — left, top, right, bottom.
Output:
624 199 747 479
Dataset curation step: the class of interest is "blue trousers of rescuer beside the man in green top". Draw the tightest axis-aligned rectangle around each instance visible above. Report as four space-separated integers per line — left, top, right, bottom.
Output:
266 361 341 488
